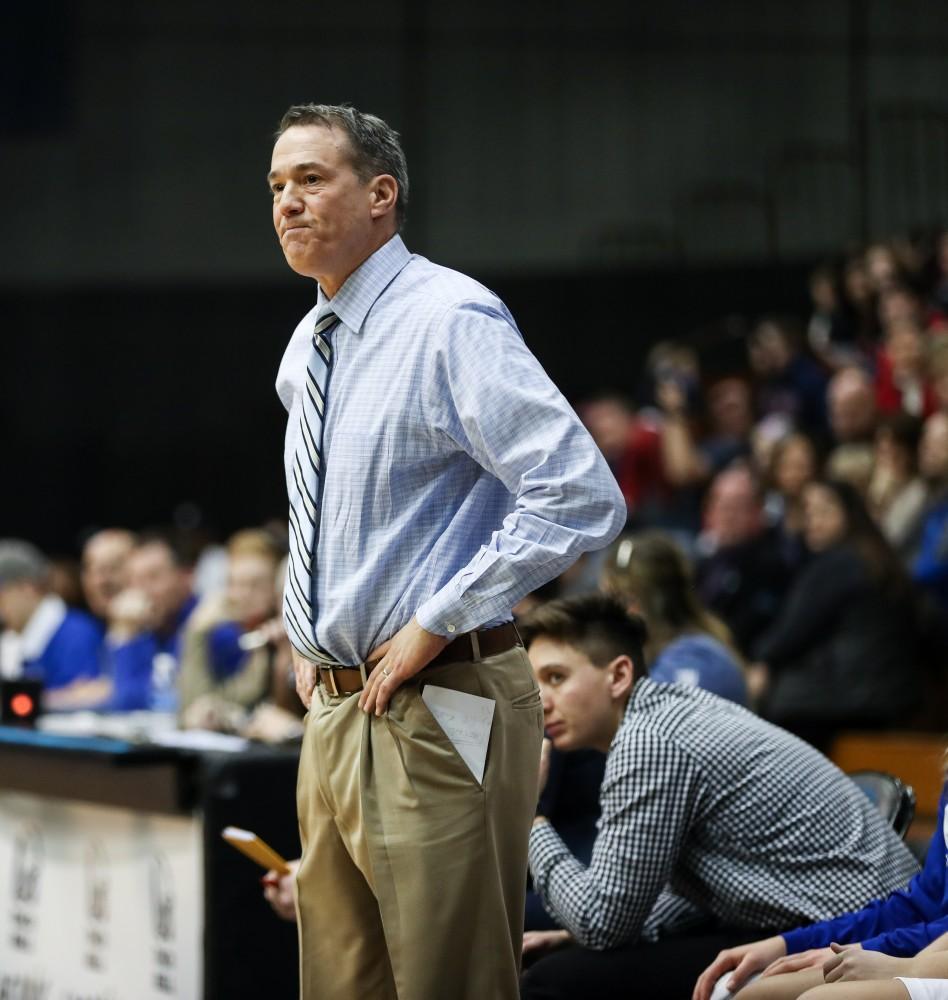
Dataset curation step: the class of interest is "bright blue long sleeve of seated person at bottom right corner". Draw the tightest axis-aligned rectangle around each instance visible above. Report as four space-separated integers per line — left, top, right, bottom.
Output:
783 786 948 958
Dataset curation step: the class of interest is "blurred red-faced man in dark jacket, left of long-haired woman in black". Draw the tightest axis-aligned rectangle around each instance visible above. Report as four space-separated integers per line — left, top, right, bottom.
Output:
696 466 793 655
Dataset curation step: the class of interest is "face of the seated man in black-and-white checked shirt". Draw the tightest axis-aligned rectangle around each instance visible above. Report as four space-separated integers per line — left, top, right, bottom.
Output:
527 636 617 750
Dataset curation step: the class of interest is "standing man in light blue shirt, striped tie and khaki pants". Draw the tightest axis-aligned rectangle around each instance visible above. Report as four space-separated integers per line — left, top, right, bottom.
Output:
269 105 625 1000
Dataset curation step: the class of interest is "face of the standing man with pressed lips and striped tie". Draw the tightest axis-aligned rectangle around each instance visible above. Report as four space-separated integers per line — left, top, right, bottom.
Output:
268 125 375 286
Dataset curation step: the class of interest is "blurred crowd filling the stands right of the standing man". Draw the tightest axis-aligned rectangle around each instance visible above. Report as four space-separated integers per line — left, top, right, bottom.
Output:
549 233 948 748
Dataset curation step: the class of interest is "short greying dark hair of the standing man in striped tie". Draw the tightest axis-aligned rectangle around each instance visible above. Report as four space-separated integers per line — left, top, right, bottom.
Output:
275 104 408 229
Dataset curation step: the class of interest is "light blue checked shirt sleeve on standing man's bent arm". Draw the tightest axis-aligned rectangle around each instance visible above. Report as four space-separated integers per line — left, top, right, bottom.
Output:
417 303 626 635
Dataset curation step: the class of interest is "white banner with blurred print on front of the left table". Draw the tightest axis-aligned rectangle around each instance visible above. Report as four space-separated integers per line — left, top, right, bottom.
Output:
0 791 204 1000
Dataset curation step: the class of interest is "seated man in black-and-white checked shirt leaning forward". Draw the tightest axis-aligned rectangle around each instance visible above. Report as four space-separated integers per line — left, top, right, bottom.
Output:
521 595 916 1000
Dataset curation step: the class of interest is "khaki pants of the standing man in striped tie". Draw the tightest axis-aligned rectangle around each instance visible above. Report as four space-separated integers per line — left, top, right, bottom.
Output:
297 647 543 1000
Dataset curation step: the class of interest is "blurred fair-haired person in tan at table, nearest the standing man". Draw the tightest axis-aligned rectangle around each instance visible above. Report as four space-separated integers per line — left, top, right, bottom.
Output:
178 529 287 729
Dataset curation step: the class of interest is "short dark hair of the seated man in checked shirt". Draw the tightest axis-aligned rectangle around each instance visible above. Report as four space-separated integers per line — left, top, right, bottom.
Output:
519 594 648 680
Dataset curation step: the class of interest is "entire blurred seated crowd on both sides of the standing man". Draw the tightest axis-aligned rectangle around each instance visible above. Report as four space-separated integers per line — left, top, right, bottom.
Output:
0 234 948 746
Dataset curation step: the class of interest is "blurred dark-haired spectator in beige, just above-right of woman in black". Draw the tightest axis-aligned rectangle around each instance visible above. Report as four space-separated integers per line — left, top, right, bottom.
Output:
868 413 927 554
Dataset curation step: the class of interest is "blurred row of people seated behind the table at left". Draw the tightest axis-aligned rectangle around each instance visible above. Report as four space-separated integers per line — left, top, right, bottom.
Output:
0 524 302 742
